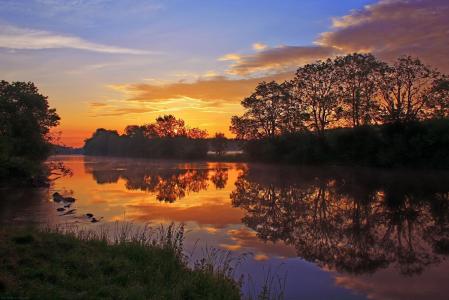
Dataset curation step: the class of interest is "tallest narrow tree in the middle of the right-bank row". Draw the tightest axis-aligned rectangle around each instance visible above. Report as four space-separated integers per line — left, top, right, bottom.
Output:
334 53 384 127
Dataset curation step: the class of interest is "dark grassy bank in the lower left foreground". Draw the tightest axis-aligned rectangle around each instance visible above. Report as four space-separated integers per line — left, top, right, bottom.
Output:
0 228 240 299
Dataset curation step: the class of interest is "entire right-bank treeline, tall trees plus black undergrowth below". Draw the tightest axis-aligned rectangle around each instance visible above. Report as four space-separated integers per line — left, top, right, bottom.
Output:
230 54 449 168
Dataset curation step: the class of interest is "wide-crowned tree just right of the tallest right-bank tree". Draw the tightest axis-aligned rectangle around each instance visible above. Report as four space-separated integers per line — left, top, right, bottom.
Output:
380 56 438 123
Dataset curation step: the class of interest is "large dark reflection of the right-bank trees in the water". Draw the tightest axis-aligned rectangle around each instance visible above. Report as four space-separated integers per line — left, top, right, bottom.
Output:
231 167 449 275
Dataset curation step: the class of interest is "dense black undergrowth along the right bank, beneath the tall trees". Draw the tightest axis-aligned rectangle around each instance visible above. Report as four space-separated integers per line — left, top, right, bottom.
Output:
245 119 449 169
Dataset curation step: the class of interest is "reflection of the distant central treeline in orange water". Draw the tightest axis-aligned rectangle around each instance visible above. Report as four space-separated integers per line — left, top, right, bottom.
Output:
85 163 228 203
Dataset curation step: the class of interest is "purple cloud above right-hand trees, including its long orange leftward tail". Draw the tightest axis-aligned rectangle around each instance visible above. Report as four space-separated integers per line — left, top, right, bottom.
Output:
220 0 449 75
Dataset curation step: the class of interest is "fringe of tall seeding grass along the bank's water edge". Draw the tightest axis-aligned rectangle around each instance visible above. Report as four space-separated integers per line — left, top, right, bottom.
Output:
42 221 286 300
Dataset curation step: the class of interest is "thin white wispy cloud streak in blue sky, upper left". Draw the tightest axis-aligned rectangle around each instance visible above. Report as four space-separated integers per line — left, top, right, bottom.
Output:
0 25 150 55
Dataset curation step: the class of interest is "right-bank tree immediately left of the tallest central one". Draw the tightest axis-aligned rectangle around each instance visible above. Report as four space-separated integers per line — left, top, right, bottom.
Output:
293 59 342 135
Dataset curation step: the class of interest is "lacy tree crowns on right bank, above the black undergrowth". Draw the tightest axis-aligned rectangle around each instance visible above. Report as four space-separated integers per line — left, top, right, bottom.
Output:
230 53 449 140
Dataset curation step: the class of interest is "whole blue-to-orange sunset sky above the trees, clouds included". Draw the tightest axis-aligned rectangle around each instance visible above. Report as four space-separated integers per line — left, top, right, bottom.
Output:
0 0 449 147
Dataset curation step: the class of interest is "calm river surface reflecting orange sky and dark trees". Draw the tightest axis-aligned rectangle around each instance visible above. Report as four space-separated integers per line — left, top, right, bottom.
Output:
0 156 449 299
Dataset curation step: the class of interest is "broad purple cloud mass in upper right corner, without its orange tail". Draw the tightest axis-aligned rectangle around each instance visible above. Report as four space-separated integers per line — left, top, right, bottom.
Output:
317 0 449 71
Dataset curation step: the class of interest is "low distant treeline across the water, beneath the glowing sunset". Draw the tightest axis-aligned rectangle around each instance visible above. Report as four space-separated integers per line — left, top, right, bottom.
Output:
84 115 212 159
